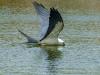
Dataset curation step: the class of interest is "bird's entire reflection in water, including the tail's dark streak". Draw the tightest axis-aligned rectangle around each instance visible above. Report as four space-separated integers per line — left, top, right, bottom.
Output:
24 44 62 75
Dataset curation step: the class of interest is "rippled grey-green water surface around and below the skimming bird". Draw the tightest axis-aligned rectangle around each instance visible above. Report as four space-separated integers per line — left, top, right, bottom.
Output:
0 4 100 75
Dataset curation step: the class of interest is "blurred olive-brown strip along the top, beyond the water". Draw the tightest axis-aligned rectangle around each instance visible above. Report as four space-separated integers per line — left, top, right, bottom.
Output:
0 0 100 11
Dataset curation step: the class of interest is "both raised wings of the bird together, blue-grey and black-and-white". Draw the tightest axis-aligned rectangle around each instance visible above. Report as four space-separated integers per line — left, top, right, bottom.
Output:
33 1 64 41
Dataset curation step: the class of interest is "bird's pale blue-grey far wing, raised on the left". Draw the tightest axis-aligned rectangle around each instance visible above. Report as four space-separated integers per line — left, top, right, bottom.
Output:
33 1 50 39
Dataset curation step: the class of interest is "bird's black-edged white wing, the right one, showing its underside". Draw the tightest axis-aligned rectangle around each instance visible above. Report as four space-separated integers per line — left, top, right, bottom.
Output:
41 8 64 41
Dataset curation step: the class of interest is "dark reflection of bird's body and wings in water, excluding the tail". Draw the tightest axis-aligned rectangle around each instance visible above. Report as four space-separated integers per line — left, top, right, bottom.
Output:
42 46 62 75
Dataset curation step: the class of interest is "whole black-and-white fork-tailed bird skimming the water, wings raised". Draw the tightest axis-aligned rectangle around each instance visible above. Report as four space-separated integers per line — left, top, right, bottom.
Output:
18 1 65 46
